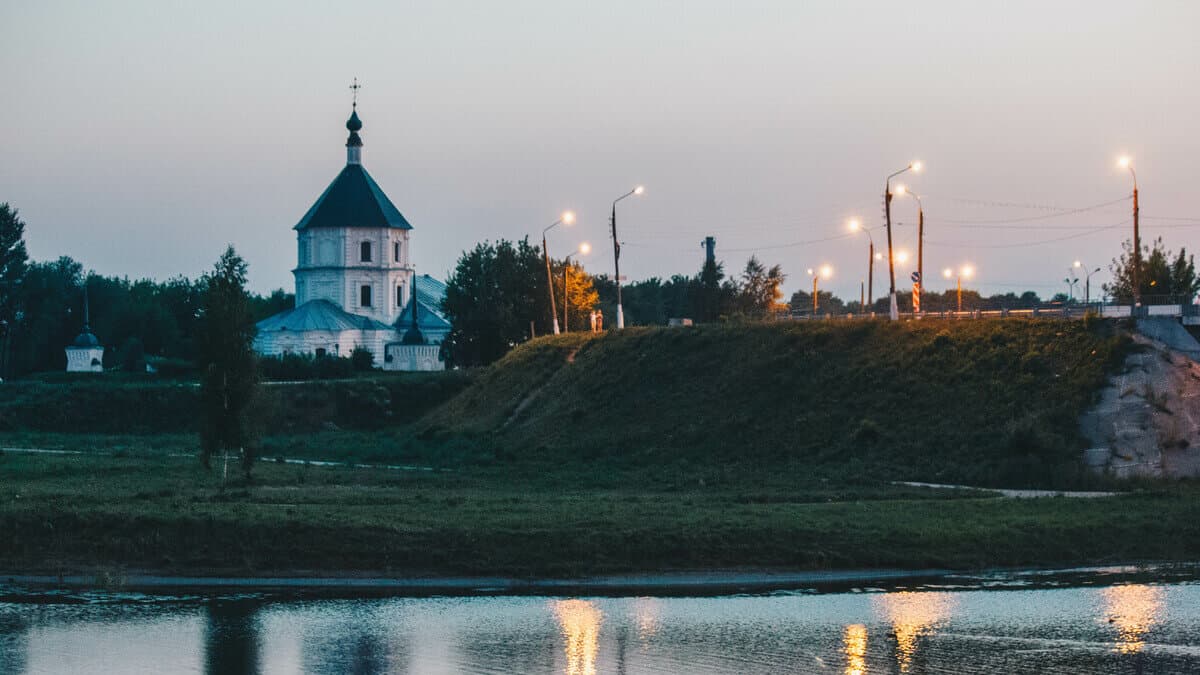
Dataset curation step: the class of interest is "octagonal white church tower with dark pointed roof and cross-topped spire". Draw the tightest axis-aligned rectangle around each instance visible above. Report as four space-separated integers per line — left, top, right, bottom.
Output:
293 88 413 324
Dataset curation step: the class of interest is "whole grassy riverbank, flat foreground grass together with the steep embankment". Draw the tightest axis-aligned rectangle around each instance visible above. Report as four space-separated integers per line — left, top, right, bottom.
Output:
0 321 1180 575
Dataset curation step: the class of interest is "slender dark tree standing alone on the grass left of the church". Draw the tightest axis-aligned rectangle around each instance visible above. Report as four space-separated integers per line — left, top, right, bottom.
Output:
198 246 258 478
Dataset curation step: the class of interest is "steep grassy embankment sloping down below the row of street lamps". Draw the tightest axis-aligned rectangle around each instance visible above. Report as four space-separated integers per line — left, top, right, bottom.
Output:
415 319 1129 488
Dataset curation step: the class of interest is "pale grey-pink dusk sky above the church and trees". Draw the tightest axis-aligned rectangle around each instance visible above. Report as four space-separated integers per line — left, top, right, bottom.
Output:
0 0 1200 299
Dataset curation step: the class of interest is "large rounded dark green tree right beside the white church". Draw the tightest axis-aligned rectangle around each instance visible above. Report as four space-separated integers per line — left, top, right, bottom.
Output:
442 238 549 366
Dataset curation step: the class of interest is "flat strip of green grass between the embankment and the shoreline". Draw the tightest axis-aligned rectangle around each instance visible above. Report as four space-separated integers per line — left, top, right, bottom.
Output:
0 452 1200 575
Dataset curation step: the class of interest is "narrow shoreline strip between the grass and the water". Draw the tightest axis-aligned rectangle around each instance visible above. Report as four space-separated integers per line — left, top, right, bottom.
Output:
0 562 1200 602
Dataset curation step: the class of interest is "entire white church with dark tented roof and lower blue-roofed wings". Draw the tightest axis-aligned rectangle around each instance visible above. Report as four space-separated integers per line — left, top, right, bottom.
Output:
254 102 450 370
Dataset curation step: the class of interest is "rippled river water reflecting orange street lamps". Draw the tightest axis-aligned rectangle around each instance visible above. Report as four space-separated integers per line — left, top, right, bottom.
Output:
0 571 1200 675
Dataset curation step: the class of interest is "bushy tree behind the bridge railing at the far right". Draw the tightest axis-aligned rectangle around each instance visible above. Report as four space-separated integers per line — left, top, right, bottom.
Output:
1104 238 1200 304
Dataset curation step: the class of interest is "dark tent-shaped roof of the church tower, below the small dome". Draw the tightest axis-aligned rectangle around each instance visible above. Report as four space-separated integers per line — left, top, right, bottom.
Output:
295 165 413 229
